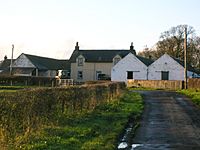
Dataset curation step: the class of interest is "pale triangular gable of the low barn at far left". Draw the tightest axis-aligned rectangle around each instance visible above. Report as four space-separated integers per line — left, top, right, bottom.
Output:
13 54 36 68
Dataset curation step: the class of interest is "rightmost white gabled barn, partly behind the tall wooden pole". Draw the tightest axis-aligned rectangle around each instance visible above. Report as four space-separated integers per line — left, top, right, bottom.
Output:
147 54 198 80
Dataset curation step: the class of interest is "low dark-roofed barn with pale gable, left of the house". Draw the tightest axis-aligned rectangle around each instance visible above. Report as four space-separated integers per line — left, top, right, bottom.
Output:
12 53 70 77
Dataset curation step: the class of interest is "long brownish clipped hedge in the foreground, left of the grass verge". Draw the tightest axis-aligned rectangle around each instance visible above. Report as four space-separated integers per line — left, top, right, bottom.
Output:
0 82 125 145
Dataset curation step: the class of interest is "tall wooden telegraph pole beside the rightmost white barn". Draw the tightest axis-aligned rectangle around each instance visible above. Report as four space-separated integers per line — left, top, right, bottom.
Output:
184 26 187 89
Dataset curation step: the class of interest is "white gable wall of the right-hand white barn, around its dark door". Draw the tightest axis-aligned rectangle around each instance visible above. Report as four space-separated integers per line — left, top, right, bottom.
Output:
148 54 184 80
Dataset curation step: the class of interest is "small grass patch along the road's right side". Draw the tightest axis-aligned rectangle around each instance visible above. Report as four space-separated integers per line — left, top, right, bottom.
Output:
178 90 200 107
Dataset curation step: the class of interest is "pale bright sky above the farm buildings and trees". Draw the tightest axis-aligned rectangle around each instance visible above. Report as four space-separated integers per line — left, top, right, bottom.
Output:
0 0 200 60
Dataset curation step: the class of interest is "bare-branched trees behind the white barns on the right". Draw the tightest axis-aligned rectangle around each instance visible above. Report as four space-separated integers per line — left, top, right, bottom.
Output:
138 25 200 70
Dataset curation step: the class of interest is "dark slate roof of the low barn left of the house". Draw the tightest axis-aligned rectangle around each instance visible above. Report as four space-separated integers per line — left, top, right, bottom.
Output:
24 54 70 70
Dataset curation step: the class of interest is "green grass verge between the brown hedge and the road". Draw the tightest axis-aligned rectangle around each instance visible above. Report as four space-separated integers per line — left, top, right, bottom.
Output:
11 92 143 150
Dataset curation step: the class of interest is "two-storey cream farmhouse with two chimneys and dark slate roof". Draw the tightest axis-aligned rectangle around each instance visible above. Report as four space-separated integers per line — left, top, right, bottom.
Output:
70 42 135 82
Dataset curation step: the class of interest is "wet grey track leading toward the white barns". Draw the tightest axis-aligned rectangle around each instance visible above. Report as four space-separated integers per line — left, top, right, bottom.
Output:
132 91 200 150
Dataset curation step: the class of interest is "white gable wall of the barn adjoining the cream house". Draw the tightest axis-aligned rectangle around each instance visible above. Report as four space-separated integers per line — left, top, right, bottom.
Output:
111 53 147 82
